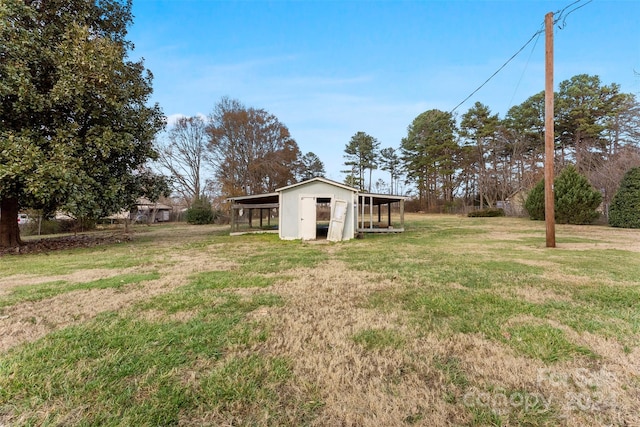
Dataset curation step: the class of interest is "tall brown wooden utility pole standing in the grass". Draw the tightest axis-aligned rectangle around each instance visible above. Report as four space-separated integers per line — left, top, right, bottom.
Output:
544 12 556 248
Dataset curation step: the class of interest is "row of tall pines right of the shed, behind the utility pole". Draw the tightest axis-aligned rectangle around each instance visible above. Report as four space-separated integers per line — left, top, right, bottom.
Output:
345 74 640 211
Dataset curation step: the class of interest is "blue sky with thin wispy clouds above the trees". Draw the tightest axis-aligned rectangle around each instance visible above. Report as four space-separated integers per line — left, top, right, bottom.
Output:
129 0 640 181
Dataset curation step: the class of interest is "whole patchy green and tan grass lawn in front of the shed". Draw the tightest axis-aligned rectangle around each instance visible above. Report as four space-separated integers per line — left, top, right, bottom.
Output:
0 215 640 426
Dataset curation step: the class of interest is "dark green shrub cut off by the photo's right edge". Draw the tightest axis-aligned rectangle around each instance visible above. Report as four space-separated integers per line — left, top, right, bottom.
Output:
609 167 640 228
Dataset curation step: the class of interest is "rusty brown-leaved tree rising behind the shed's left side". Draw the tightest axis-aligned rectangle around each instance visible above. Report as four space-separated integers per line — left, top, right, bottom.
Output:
207 97 300 196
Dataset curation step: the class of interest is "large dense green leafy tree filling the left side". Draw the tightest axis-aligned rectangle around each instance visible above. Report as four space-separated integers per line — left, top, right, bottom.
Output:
0 0 164 247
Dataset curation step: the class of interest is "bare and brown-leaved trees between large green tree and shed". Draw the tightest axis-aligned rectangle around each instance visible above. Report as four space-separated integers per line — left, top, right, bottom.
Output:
156 97 325 205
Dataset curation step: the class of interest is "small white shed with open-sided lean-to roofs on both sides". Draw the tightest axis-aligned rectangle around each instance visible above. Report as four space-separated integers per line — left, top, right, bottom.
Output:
227 178 405 241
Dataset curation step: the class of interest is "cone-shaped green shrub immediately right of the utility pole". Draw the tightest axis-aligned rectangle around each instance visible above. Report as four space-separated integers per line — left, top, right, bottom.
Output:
554 165 602 224
